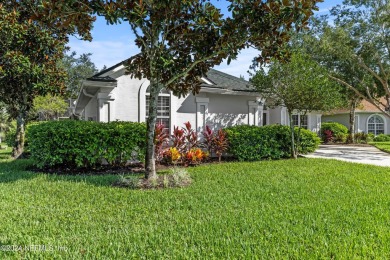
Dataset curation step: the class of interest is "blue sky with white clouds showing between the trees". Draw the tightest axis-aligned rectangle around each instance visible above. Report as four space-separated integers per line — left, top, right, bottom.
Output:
68 0 342 79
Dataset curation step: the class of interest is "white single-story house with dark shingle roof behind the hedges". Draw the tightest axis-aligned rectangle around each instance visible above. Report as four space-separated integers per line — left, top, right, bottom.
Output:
75 59 321 133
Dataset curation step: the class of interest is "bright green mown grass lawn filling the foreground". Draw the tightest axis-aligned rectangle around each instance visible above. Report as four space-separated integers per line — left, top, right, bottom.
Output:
0 148 390 259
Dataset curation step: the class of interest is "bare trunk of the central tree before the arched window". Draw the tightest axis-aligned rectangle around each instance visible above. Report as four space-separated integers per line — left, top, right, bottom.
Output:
145 81 162 179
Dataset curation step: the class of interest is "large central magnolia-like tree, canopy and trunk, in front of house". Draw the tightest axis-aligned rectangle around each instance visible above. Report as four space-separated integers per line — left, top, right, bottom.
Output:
99 0 319 178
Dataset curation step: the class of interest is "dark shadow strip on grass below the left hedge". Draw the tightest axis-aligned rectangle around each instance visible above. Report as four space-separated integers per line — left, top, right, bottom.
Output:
0 158 126 187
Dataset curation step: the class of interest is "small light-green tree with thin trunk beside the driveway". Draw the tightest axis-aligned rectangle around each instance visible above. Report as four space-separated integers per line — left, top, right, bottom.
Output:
251 53 342 158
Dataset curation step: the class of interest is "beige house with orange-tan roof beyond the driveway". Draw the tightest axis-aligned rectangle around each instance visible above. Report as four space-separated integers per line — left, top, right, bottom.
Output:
322 99 390 135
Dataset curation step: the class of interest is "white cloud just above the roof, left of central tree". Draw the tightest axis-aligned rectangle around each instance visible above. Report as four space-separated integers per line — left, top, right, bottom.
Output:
69 38 138 69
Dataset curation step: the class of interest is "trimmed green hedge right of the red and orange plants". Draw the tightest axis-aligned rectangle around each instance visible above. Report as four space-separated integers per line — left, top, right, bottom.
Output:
225 125 320 161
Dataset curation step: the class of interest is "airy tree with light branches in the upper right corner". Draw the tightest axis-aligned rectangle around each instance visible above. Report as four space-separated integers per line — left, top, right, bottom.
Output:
316 0 390 116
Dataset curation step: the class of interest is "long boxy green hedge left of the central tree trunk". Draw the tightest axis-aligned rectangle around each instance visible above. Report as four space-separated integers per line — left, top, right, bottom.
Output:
27 120 146 168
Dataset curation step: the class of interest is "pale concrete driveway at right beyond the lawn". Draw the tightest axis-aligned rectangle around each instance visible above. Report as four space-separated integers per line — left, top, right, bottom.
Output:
304 145 390 167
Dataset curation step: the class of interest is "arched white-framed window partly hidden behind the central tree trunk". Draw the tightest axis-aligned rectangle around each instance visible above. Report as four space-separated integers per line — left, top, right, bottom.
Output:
145 87 171 133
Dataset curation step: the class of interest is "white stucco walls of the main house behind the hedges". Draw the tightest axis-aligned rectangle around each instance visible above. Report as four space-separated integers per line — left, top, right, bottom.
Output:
84 74 317 132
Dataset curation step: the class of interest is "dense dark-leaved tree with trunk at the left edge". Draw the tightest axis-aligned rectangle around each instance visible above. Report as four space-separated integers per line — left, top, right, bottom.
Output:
0 0 95 157
